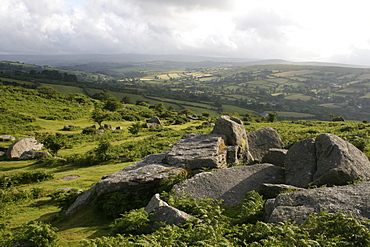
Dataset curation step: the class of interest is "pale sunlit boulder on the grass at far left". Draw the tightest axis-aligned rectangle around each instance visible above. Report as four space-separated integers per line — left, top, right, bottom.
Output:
6 137 43 159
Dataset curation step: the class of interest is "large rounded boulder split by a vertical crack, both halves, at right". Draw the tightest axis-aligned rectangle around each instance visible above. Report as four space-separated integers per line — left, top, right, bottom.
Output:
285 134 370 188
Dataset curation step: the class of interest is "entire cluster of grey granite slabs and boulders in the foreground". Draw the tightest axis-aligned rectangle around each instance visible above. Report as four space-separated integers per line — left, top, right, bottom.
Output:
66 116 370 227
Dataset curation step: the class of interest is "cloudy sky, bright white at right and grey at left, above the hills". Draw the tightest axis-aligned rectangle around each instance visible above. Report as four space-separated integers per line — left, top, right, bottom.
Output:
0 0 370 65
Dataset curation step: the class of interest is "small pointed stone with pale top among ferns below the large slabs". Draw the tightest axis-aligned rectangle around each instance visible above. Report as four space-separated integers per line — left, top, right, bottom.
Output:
145 194 192 225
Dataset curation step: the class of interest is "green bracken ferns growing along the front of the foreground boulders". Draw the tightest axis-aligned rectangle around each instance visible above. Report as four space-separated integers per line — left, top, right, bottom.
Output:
81 191 370 247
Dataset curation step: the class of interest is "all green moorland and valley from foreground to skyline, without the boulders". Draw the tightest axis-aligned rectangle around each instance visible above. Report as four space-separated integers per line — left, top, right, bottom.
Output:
0 59 370 246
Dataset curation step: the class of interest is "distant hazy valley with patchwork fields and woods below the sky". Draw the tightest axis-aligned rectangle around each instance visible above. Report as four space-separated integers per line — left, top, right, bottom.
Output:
0 60 370 121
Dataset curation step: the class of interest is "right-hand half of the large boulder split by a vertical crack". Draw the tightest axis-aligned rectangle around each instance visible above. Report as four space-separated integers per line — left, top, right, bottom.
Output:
313 134 370 185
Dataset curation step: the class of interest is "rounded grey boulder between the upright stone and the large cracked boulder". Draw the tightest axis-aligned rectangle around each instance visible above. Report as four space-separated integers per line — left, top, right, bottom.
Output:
247 127 284 162
